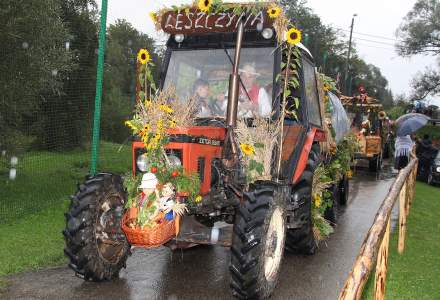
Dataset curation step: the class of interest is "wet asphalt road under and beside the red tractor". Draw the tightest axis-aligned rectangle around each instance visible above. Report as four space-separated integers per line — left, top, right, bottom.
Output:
0 163 393 299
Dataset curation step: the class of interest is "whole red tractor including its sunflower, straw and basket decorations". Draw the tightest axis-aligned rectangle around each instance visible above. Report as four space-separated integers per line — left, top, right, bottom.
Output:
63 0 352 298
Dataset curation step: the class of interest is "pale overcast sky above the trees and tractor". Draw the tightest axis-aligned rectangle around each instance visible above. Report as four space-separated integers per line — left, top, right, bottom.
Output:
97 0 440 104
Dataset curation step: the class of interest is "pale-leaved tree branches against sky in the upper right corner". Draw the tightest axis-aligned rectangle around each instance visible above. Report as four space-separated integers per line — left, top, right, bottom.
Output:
397 0 440 100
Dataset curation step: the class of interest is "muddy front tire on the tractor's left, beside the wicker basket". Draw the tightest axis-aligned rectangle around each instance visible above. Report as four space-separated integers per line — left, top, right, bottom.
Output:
63 173 130 281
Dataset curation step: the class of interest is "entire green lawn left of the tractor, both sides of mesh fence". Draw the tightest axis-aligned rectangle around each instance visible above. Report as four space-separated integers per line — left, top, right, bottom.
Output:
0 143 131 278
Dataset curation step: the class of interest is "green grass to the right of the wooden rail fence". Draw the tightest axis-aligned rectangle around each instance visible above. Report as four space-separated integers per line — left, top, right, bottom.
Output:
363 183 440 300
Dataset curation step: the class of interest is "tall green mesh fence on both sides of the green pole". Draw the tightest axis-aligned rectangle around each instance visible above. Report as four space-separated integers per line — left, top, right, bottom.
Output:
0 0 157 223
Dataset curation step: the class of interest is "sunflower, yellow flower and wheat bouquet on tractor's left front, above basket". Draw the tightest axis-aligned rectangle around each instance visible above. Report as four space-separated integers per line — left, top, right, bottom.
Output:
125 49 200 209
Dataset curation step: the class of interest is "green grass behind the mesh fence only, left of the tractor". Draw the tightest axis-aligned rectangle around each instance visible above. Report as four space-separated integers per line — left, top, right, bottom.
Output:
0 142 131 224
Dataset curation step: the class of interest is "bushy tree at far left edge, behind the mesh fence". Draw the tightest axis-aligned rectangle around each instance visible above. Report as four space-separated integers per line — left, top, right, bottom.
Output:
0 0 74 151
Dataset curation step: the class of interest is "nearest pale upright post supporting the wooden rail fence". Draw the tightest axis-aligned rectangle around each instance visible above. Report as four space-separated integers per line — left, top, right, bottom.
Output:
374 218 391 300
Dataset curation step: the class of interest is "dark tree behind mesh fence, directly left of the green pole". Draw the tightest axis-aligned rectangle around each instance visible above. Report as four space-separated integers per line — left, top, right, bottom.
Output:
37 0 98 150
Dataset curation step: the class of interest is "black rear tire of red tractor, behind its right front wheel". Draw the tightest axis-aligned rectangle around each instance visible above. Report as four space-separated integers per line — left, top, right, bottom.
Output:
286 144 320 255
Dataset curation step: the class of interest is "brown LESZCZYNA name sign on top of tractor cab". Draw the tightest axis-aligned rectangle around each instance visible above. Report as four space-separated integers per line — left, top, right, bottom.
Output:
161 10 272 34
